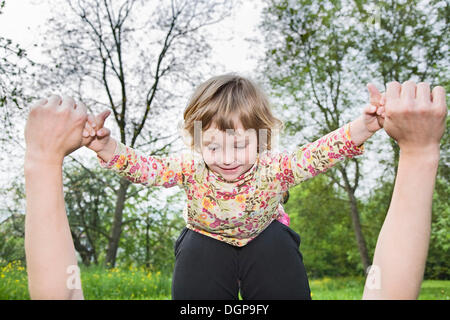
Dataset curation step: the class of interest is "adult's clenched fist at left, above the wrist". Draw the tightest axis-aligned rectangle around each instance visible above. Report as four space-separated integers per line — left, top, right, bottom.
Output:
25 95 87 165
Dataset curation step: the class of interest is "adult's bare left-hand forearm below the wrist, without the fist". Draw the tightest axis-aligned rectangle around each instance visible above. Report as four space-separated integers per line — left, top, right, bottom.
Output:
25 160 82 299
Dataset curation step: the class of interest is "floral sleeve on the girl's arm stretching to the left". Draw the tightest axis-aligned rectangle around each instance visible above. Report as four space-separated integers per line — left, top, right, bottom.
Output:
97 141 194 188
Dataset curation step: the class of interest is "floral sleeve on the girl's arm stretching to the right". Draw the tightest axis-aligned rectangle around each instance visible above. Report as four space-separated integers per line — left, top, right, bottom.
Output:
276 123 364 190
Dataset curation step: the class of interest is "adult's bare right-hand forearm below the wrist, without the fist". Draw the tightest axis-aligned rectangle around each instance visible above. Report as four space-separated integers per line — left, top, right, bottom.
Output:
364 148 439 299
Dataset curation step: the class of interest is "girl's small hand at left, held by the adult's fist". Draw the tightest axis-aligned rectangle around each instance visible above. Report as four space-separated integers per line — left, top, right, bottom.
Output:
83 110 111 153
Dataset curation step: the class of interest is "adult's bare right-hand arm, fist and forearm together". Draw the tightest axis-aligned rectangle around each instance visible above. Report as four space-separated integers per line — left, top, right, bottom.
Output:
363 81 447 299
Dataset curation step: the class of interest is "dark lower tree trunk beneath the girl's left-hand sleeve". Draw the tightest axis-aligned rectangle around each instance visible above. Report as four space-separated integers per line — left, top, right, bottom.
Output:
105 178 130 268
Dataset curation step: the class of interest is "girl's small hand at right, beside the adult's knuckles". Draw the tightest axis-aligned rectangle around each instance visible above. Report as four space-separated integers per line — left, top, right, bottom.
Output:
363 83 385 133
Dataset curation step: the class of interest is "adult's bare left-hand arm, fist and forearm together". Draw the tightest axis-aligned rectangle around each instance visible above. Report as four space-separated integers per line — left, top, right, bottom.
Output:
24 96 88 299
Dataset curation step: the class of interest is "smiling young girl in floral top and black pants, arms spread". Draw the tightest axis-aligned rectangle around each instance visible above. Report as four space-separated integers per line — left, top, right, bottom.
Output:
84 74 380 299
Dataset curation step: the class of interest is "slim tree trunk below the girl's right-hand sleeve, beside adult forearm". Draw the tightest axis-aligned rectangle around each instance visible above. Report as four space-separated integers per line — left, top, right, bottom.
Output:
341 169 371 272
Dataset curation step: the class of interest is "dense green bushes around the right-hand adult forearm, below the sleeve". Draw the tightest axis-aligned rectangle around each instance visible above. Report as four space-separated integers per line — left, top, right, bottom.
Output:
285 166 450 279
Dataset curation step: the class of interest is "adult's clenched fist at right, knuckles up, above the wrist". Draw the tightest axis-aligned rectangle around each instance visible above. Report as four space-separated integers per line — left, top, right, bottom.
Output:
384 81 447 153
